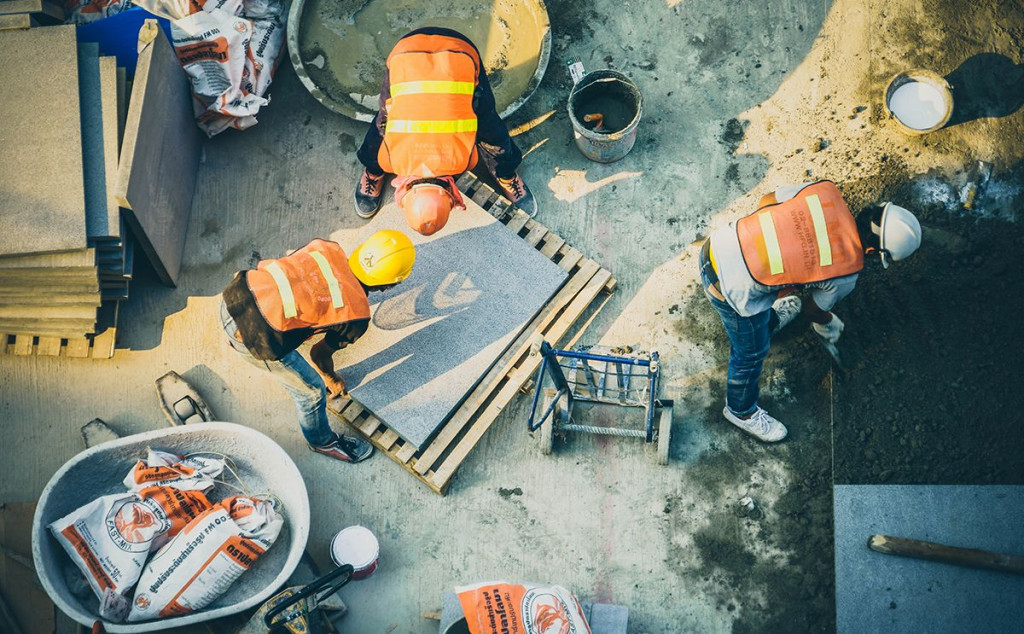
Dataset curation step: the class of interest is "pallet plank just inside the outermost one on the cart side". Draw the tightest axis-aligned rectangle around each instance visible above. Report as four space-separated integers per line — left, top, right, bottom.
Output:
415 260 600 473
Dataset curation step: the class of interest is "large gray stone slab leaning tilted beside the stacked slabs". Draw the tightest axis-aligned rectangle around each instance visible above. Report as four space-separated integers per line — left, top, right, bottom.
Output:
116 29 204 286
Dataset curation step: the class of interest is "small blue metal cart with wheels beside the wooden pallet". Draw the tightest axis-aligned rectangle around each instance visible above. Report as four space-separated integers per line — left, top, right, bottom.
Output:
526 341 674 465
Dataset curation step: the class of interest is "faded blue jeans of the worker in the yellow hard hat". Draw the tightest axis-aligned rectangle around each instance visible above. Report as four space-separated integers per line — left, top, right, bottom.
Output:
220 302 334 447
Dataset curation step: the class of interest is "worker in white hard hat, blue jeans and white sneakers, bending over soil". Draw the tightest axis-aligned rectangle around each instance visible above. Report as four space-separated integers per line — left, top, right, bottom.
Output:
699 180 921 442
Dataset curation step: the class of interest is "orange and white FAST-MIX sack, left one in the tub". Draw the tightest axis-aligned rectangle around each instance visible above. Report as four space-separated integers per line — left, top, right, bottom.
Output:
49 482 212 621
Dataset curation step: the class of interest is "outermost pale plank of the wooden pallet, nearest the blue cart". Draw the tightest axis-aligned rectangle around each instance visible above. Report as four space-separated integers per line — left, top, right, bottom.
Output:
431 269 611 491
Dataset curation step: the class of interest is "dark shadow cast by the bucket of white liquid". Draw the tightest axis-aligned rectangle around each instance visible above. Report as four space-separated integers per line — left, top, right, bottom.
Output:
945 53 1024 126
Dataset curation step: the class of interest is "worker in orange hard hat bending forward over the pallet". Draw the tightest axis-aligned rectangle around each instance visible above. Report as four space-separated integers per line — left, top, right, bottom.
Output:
355 27 537 236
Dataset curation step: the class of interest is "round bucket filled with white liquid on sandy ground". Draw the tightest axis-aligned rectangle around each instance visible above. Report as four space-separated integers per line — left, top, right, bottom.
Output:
886 70 953 135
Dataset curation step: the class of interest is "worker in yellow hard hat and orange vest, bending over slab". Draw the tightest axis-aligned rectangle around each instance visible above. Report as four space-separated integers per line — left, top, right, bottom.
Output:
220 230 416 462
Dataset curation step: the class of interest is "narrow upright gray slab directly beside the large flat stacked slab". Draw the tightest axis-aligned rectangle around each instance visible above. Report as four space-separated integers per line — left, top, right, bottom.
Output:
78 42 113 238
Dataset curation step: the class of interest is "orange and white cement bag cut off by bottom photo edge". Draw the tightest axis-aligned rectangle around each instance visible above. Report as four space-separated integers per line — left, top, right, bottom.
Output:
456 582 590 634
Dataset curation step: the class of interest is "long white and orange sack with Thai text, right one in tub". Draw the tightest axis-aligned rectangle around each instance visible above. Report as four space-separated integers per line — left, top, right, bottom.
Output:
128 496 285 622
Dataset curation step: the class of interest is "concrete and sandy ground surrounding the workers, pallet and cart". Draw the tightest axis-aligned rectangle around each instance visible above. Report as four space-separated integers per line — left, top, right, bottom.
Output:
0 0 1024 634
